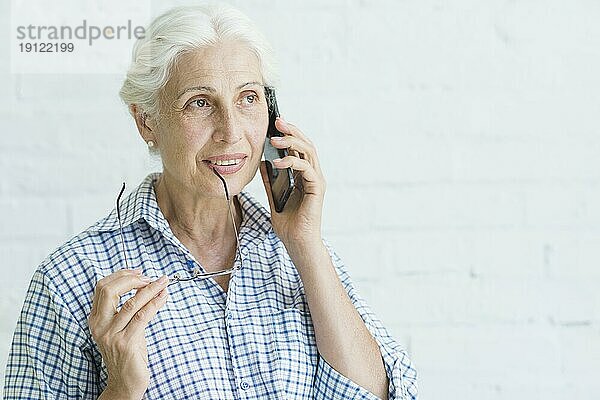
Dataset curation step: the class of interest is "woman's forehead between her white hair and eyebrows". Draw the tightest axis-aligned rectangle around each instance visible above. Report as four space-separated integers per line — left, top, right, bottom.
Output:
165 43 263 99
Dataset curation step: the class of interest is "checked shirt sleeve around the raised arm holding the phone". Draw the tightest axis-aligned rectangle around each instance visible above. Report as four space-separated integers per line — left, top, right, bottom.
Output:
315 242 417 400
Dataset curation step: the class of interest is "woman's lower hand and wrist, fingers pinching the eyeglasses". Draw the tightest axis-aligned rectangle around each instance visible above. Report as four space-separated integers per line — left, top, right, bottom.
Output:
88 269 169 399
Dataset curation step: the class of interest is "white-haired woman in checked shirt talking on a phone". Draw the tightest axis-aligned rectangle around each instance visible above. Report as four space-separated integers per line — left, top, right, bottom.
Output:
5 6 417 399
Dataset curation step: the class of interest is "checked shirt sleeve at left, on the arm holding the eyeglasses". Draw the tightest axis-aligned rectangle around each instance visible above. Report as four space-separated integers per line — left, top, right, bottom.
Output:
4 269 99 400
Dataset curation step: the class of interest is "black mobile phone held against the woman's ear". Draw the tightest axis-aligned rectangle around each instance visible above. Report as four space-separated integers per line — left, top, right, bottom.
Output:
263 87 294 212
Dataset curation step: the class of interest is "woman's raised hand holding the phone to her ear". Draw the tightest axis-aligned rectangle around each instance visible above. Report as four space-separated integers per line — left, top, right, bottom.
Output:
260 118 325 251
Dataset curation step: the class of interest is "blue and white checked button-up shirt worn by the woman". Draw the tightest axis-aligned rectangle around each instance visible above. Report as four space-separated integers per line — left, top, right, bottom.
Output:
4 174 417 400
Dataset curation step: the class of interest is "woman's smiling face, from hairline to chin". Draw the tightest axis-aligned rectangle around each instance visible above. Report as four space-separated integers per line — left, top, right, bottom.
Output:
155 42 269 197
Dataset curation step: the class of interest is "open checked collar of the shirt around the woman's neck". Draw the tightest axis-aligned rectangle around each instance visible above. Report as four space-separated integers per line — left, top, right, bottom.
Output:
90 172 272 247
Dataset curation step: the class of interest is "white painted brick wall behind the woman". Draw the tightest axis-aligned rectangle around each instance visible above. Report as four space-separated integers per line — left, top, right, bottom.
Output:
0 0 600 399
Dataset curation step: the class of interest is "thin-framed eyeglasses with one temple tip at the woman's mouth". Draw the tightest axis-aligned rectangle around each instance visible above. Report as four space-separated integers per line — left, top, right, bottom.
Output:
117 169 242 285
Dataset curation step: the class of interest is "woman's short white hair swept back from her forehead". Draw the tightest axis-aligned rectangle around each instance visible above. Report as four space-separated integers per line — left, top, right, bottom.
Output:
119 3 278 116
